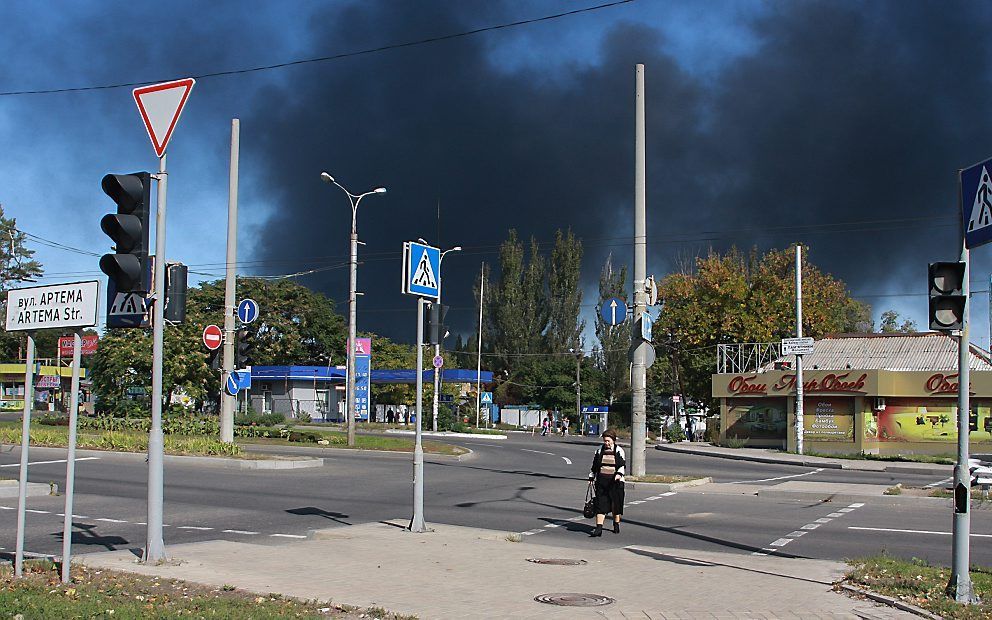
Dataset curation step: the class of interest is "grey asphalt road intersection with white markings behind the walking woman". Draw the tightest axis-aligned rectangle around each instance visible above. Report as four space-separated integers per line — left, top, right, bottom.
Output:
0 434 992 565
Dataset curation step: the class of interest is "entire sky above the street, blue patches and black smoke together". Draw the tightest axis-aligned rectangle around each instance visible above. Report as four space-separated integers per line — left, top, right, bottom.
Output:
0 0 992 346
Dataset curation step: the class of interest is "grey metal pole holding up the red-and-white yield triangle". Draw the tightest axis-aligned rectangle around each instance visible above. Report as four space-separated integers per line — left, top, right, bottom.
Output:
142 154 168 563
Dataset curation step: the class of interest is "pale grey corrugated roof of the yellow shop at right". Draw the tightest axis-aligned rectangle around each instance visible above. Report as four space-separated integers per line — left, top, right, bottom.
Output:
764 332 992 371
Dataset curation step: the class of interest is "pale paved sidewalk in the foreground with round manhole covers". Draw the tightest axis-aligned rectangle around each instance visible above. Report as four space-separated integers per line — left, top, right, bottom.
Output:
79 520 915 619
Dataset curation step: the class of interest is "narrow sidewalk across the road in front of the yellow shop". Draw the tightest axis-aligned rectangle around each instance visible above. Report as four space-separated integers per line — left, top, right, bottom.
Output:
655 442 954 476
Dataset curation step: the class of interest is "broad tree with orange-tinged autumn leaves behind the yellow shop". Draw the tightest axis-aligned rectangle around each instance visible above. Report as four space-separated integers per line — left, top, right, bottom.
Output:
654 247 871 402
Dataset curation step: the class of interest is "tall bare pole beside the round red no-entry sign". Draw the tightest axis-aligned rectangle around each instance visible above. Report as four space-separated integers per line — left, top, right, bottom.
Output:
220 118 241 443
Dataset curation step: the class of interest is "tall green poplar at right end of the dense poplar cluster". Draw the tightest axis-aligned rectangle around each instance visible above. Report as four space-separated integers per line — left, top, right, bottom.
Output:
547 229 585 353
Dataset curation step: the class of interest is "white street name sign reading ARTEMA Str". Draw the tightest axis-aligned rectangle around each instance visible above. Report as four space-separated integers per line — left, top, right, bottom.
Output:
7 281 100 332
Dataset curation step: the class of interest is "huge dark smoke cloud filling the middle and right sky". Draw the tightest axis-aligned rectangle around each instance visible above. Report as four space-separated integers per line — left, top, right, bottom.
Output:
246 2 992 341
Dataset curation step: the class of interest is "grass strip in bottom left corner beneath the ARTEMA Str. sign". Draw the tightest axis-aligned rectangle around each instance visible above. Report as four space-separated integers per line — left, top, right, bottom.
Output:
0 561 412 620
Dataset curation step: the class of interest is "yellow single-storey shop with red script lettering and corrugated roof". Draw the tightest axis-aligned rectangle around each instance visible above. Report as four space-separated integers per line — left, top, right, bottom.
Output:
713 332 992 456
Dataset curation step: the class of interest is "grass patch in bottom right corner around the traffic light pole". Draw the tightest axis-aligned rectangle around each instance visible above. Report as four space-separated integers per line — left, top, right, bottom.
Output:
847 555 992 620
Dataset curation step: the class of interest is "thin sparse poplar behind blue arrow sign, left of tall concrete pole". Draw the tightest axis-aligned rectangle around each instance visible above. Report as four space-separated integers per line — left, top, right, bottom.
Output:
596 254 631 405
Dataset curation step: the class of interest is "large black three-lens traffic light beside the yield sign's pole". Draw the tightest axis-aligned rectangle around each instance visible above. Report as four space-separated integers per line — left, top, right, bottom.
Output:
100 172 152 293
